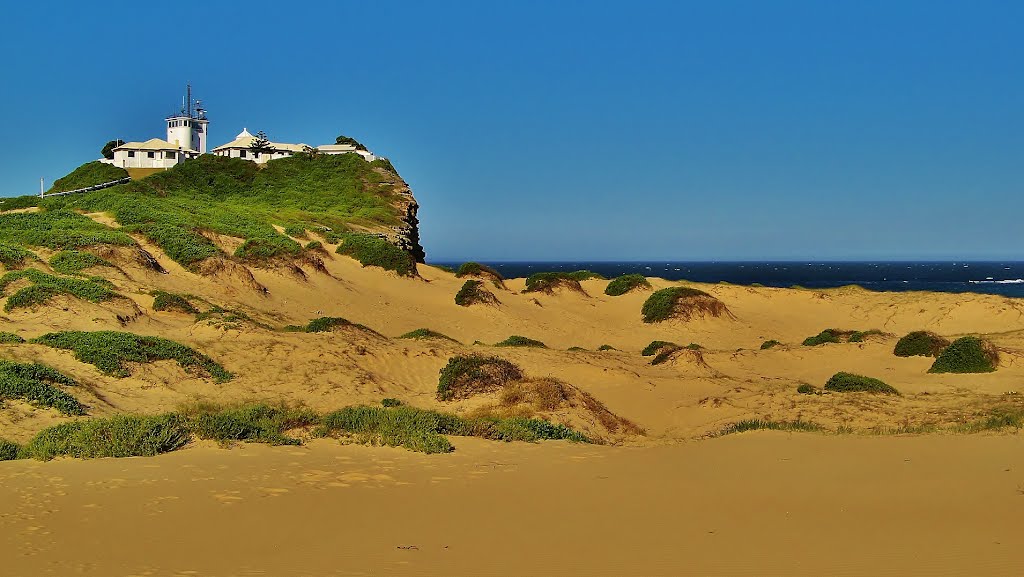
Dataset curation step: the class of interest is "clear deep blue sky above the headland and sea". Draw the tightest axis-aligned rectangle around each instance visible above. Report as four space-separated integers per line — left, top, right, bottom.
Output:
0 0 1024 260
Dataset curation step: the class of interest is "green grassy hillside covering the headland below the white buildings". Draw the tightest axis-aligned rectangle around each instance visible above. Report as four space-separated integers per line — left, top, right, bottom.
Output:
0 155 415 266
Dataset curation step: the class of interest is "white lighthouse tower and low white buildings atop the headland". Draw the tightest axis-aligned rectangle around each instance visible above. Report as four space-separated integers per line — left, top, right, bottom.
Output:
108 85 378 169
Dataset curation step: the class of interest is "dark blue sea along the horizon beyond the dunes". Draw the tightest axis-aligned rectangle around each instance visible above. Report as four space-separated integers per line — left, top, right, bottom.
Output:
432 261 1024 297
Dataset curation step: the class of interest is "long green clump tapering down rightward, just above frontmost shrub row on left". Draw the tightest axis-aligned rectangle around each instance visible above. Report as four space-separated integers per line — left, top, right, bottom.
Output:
32 331 233 382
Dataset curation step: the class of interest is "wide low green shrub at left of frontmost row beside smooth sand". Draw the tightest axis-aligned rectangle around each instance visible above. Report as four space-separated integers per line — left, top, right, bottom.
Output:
24 415 189 461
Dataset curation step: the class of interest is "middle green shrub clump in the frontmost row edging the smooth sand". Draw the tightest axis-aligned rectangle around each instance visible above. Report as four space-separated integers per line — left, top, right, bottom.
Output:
186 404 319 445
